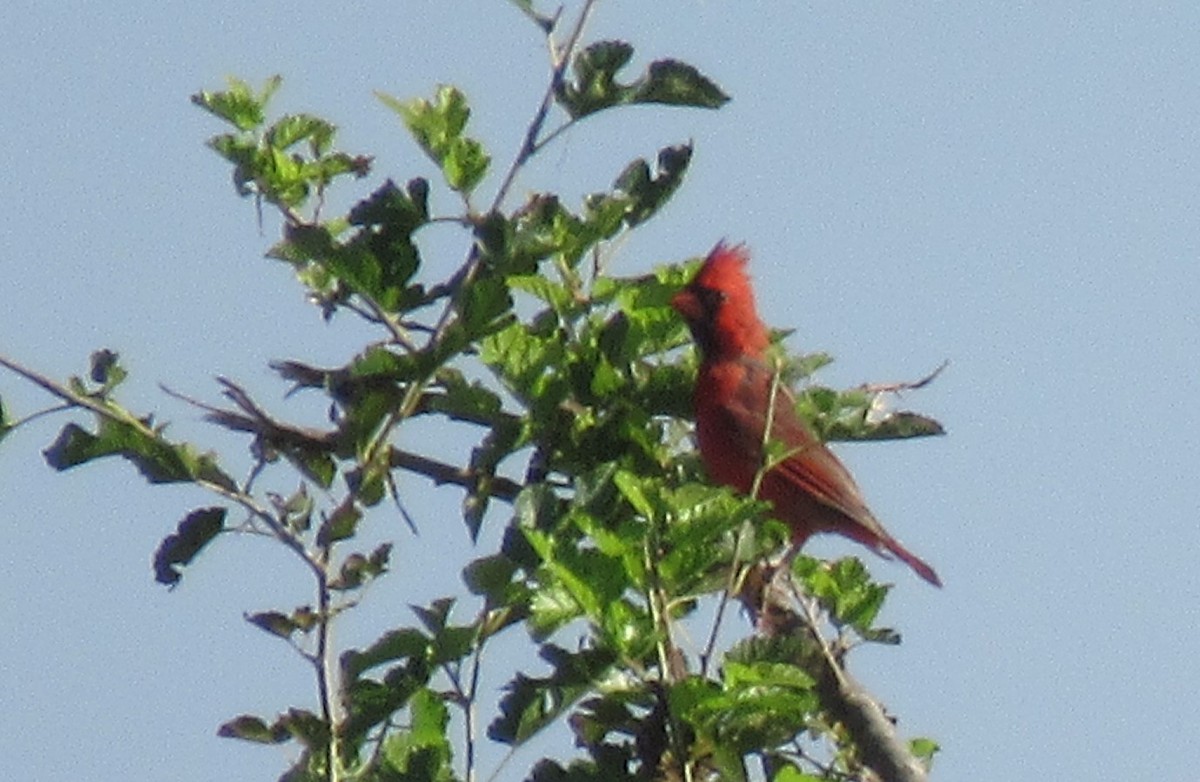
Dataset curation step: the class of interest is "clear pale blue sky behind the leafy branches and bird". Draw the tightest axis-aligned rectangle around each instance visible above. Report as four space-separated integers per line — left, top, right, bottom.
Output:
0 0 1200 782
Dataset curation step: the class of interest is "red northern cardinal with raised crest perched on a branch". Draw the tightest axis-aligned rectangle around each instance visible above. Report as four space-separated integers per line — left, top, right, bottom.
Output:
671 242 942 587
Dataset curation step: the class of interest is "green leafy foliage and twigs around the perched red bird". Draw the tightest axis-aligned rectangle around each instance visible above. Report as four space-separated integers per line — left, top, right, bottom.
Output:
0 1 940 781
